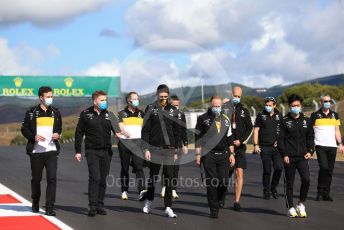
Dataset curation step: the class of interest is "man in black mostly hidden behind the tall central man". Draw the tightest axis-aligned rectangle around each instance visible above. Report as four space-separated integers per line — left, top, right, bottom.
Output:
161 95 188 199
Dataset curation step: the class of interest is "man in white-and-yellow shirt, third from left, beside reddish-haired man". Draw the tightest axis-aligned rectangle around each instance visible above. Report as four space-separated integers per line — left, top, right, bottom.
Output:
118 92 146 201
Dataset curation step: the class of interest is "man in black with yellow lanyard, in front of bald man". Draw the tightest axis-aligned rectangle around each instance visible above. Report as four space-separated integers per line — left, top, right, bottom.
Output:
195 96 235 218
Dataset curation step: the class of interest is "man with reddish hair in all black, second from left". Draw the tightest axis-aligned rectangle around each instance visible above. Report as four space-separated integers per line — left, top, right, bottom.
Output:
75 91 120 217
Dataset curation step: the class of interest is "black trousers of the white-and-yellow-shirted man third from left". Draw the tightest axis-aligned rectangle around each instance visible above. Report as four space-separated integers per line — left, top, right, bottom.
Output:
118 139 146 193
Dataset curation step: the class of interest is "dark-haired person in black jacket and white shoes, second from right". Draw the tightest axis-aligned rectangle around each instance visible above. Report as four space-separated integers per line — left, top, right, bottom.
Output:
277 94 314 218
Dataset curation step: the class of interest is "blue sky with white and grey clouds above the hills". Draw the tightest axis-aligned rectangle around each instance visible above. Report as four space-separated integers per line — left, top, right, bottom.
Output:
0 0 344 93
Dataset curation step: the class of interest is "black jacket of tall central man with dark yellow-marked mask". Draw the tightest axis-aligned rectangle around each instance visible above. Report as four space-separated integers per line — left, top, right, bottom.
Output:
141 102 180 149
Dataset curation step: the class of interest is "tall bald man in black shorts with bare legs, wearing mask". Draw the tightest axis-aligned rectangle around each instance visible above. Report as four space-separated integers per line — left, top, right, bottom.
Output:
223 86 253 211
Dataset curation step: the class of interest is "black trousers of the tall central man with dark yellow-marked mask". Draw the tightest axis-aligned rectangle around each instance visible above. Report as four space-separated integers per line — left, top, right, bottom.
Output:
146 148 174 207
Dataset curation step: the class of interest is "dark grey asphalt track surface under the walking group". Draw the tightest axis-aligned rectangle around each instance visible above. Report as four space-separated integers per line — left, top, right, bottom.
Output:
0 144 344 230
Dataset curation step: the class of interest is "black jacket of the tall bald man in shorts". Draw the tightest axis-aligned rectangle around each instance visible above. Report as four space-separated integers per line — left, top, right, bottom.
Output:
223 101 253 145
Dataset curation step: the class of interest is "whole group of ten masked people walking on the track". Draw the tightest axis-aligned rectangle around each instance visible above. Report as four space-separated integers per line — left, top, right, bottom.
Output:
21 85 344 218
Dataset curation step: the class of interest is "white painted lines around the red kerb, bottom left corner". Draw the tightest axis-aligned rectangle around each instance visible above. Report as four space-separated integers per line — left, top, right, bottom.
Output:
0 183 72 230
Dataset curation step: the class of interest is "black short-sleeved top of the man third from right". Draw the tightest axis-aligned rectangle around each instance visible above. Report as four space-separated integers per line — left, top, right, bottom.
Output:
254 109 283 146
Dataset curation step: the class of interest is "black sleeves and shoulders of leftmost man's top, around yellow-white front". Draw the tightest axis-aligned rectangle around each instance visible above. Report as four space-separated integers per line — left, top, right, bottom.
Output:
21 105 62 155
